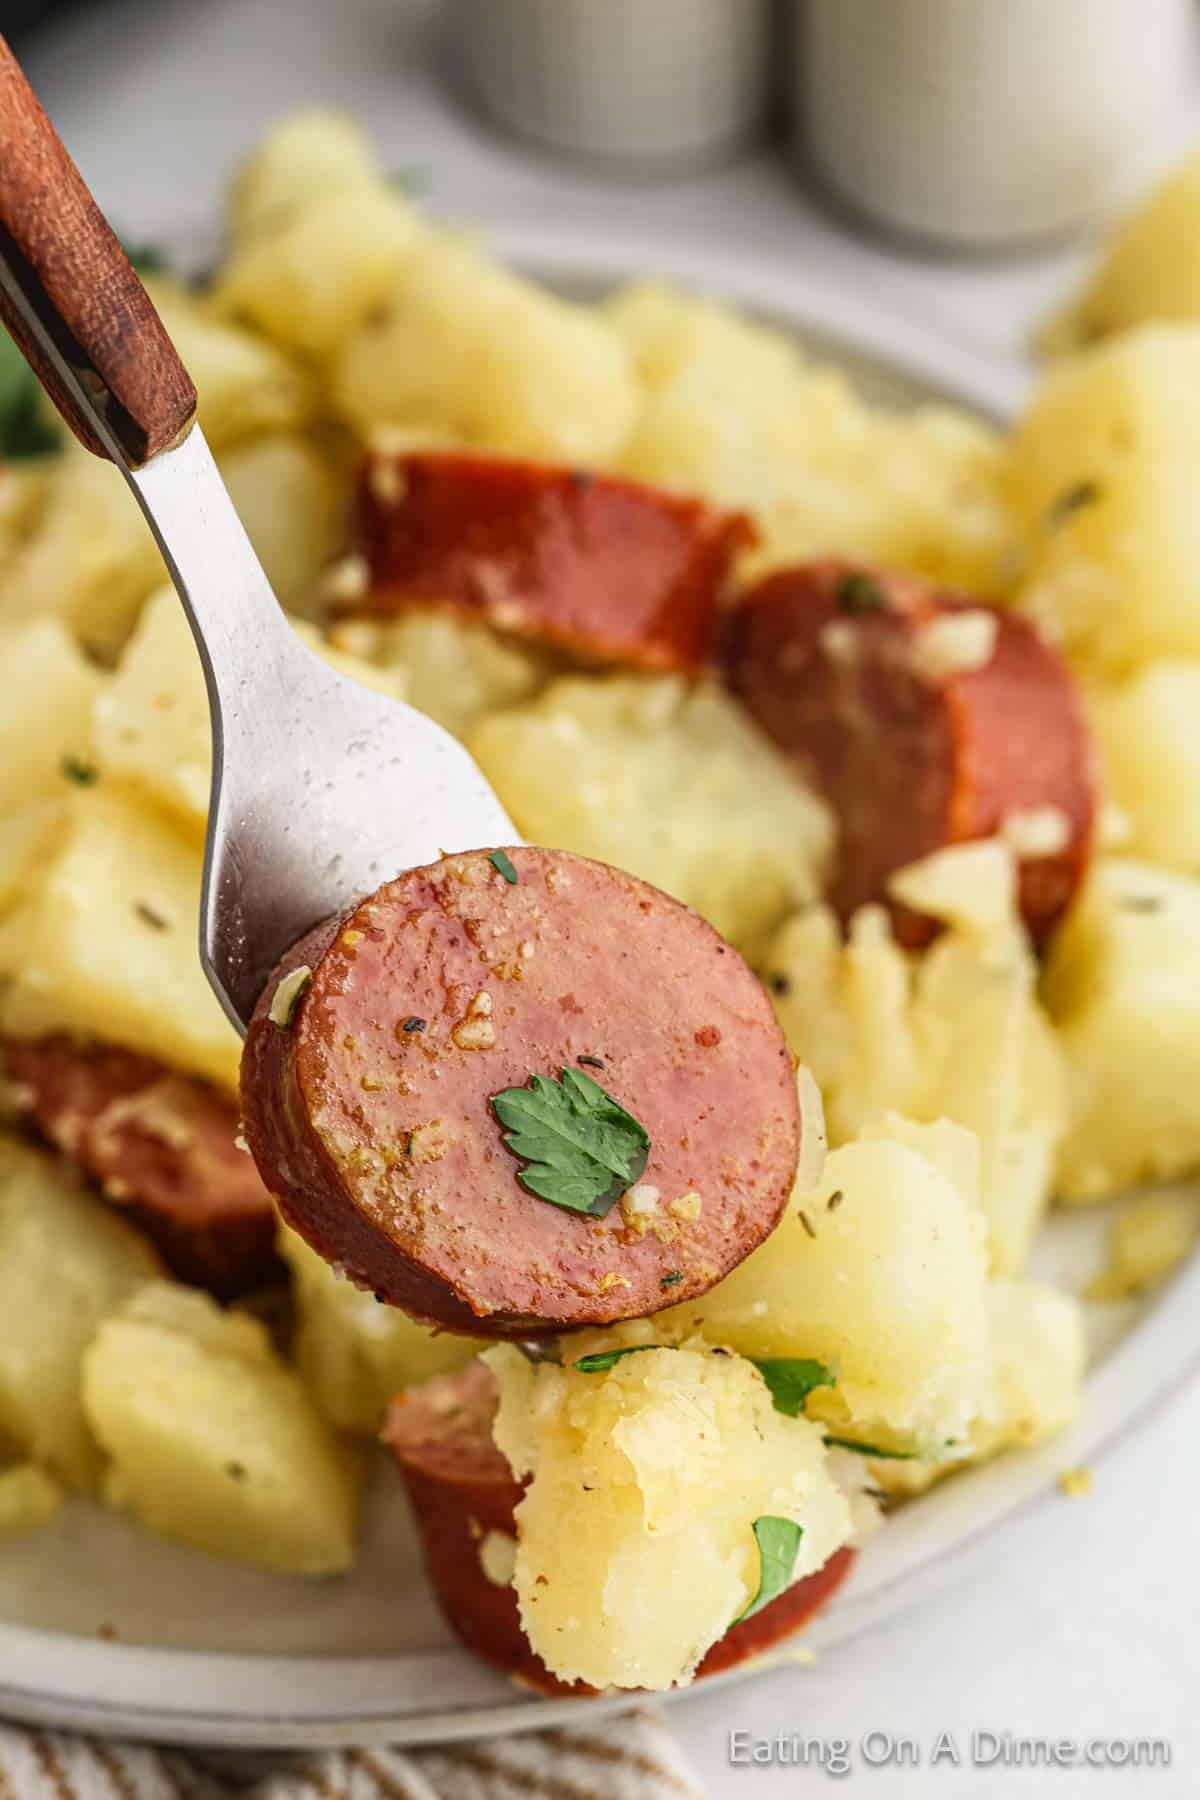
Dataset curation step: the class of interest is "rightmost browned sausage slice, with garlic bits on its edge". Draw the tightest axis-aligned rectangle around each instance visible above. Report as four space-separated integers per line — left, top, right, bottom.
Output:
727 562 1097 945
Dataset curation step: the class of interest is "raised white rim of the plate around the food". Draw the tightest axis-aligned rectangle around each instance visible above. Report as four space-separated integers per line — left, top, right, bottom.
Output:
0 223 1200 1750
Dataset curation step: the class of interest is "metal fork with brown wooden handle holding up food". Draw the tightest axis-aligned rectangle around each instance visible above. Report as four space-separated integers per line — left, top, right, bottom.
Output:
0 36 520 1035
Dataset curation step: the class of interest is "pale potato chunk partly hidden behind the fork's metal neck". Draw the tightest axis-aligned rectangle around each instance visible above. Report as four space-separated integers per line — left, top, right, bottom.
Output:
94 587 399 838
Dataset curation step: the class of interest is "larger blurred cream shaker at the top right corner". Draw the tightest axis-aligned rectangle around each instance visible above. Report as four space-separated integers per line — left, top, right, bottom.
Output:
793 0 1195 248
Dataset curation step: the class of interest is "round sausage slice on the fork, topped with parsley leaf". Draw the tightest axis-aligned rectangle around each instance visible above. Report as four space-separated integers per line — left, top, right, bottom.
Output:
243 848 801 1336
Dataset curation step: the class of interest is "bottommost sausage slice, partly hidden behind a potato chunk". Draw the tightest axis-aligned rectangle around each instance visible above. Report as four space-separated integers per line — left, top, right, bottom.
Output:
383 1363 855 1699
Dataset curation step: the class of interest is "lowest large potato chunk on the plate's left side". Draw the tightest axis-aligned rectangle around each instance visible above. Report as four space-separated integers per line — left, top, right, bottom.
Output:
83 1282 360 1575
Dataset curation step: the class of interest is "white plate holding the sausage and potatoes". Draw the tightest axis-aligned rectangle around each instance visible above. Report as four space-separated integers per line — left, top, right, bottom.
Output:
0 230 1200 1750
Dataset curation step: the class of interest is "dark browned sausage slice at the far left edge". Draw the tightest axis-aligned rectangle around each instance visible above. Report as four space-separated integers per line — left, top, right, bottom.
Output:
4 1037 279 1300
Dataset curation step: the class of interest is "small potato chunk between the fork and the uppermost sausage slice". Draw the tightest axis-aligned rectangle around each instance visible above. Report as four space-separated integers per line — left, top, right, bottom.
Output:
329 607 545 740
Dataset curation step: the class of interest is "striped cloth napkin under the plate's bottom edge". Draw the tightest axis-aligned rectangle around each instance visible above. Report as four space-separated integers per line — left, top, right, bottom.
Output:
0 1708 703 1800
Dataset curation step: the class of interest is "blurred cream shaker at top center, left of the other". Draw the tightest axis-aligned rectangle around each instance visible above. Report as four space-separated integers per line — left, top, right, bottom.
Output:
453 0 774 173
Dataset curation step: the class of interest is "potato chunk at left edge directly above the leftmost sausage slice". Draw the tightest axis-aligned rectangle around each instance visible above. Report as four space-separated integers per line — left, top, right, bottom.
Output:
0 779 241 1091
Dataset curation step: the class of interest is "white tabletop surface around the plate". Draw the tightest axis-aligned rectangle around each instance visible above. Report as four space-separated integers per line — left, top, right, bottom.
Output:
16 0 1200 1800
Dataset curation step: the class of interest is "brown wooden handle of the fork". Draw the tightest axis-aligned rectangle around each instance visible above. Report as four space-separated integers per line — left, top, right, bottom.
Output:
0 36 196 468
